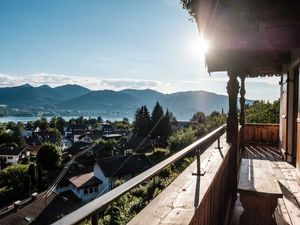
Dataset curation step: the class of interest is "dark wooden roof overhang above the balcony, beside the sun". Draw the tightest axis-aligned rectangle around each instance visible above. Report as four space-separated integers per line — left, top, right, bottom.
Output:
193 0 300 76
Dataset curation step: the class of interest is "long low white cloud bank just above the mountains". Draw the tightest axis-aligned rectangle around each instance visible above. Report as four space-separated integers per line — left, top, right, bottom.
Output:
0 73 173 93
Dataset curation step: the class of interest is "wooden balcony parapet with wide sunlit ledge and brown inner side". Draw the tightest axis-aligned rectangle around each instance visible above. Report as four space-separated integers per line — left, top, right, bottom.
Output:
128 127 241 225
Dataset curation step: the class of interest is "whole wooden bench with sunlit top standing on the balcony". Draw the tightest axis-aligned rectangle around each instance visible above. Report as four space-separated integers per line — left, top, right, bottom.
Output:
237 159 283 225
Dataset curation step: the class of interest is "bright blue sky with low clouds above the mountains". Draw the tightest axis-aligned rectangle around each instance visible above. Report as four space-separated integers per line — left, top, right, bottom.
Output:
0 0 279 100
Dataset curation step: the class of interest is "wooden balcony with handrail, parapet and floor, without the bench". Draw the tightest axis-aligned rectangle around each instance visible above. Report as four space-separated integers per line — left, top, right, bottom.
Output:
55 124 300 225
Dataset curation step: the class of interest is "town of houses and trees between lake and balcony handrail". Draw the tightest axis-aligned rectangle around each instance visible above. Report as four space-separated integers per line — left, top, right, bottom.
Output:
0 102 230 222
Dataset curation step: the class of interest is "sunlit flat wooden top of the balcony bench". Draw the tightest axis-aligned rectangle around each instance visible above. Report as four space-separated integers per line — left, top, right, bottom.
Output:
238 159 282 197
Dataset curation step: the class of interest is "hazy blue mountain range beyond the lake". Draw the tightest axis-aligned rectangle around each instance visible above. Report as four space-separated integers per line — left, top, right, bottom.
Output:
0 84 251 114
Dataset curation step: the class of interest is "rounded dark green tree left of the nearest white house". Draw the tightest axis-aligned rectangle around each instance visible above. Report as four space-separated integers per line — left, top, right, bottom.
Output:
37 143 61 170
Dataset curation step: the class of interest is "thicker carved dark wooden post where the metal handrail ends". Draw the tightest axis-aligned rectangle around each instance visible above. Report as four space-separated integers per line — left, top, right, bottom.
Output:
226 72 239 143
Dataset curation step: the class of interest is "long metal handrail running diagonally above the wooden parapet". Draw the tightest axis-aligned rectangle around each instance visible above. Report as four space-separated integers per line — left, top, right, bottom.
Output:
53 125 226 225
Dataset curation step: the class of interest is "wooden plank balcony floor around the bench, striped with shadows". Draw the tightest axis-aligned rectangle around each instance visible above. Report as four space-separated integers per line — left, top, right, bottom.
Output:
230 145 300 225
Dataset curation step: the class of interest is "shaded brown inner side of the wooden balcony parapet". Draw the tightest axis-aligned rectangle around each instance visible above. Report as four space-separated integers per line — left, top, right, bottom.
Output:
189 129 242 225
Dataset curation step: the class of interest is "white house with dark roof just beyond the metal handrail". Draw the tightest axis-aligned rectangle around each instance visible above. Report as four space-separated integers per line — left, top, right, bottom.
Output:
52 154 151 202
